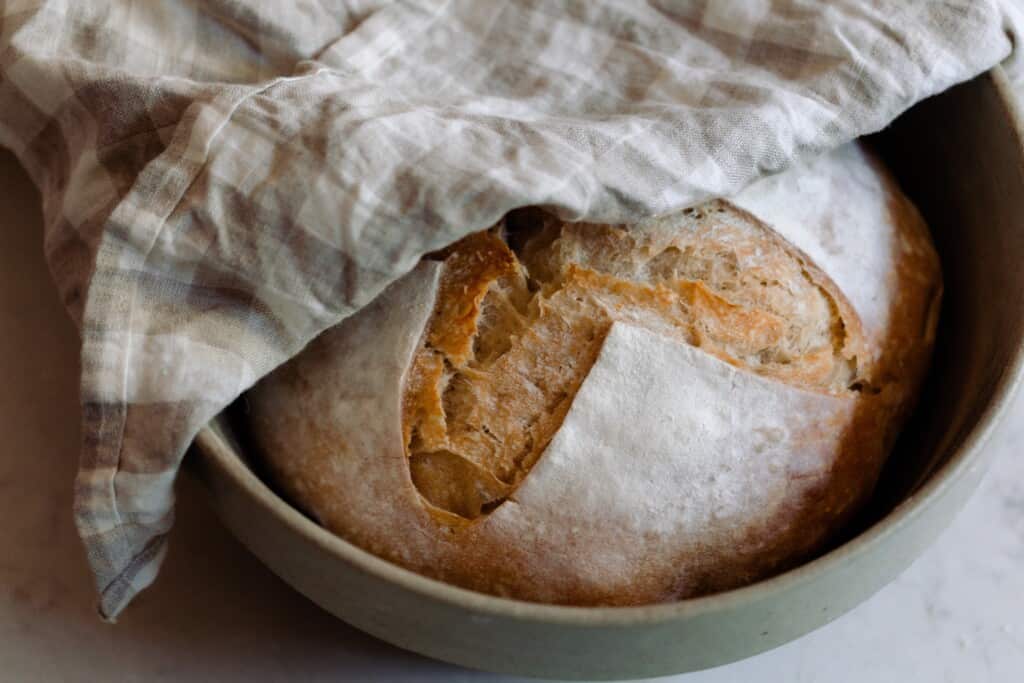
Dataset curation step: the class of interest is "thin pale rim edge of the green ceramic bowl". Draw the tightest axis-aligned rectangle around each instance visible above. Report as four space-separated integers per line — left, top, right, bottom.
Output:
195 67 1024 627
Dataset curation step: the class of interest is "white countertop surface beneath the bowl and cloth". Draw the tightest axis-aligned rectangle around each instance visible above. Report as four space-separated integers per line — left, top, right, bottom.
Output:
0 151 1024 683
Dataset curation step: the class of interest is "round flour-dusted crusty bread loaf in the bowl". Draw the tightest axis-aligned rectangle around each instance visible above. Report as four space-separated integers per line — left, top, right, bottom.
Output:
249 145 941 605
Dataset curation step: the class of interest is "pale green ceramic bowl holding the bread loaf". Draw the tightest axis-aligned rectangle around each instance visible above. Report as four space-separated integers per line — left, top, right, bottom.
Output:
194 70 1024 679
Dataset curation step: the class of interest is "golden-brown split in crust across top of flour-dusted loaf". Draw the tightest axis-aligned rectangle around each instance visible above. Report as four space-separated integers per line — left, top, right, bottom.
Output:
402 200 879 525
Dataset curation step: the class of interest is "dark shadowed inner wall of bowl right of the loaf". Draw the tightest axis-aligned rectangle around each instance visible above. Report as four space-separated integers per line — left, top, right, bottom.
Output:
850 77 1024 533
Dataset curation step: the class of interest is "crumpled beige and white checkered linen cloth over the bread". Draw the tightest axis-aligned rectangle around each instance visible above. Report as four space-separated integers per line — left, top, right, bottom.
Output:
0 0 1016 618
